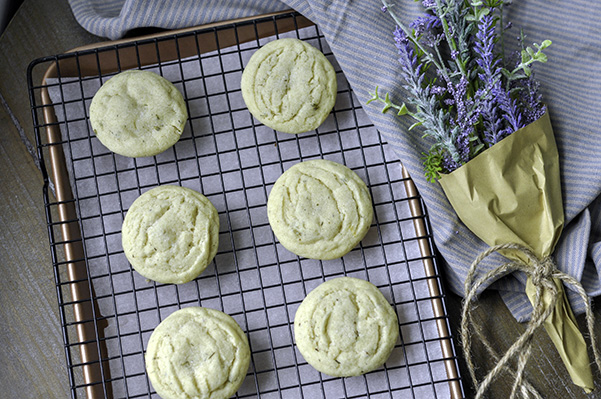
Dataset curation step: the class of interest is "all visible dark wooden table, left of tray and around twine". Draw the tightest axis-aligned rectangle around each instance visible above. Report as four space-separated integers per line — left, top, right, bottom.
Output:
0 0 601 399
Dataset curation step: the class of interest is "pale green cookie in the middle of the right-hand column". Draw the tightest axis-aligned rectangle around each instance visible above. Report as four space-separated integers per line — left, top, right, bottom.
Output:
267 159 373 260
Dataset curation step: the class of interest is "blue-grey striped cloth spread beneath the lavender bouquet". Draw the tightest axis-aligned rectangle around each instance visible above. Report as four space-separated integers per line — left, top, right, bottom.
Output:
69 0 601 321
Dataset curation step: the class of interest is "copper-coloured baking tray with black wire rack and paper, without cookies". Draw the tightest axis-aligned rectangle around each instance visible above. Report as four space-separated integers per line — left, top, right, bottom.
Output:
28 11 464 399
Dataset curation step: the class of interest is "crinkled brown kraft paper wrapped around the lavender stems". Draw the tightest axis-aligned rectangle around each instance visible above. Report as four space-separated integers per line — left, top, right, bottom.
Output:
439 113 594 392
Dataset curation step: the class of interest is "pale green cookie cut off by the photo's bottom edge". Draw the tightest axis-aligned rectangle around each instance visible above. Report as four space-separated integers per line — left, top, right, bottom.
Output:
145 307 250 399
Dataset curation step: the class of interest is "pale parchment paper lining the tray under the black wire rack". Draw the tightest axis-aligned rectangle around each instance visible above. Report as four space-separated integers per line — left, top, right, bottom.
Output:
39 18 458 398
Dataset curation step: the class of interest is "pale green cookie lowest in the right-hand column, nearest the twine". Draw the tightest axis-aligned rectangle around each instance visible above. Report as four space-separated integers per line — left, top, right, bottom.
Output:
294 277 399 377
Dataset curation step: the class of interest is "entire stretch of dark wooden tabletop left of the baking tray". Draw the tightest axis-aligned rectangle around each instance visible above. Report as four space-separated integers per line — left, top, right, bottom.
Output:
0 0 101 398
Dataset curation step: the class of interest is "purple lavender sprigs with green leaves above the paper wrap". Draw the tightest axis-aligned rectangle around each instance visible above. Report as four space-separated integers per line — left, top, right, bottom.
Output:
368 0 551 181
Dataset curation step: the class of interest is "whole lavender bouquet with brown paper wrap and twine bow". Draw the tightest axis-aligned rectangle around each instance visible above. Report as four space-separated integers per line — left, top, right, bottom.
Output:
368 0 601 397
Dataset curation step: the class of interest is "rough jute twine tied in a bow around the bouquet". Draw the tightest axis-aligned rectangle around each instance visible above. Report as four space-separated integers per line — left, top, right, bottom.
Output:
461 244 601 399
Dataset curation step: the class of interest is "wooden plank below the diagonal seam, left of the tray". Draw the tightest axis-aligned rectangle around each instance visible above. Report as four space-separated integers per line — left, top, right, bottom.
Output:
0 102 68 398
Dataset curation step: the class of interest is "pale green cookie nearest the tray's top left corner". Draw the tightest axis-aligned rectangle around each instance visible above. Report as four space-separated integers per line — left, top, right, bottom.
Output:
90 70 188 157
